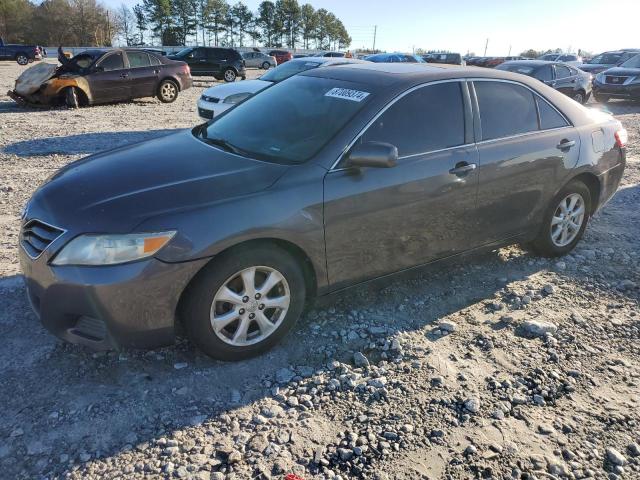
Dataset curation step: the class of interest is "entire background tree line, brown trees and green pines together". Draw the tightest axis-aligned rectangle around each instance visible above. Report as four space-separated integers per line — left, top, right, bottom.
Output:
0 0 351 50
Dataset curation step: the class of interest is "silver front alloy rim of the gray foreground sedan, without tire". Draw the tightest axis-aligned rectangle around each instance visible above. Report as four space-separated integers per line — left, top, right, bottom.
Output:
210 266 291 347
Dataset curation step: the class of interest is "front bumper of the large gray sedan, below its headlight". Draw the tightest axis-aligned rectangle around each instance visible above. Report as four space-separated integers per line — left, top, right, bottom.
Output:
19 247 207 350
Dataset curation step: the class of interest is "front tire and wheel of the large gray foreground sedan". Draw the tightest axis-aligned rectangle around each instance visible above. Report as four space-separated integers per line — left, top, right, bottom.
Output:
181 245 306 361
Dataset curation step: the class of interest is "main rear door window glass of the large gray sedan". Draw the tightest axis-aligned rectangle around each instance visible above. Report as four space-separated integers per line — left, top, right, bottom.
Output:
474 82 538 140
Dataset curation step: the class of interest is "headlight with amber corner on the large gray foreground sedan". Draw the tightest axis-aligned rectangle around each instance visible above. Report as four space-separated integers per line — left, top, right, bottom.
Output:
51 231 176 265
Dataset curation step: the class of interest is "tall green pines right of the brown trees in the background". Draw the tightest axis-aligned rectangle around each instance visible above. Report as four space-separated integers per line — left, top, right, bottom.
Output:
118 0 351 49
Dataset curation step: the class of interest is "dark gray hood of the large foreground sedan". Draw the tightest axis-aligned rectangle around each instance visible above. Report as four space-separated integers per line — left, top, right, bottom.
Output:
27 130 287 233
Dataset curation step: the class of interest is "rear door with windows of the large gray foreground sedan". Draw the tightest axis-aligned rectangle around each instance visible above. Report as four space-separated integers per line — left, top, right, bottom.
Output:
472 80 580 243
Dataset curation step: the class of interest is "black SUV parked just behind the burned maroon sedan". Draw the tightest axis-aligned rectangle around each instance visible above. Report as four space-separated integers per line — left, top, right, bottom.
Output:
168 47 247 82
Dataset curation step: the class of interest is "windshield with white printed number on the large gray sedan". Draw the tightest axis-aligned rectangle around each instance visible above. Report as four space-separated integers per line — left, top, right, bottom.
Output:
198 75 373 164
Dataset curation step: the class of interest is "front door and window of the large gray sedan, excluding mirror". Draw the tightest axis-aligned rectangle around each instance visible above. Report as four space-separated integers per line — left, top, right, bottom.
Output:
324 81 478 288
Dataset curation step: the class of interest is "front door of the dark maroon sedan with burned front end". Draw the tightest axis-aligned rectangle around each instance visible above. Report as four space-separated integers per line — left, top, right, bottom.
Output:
86 51 131 103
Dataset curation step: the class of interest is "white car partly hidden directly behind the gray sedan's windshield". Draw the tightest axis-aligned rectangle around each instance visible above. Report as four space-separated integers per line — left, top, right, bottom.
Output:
198 57 365 120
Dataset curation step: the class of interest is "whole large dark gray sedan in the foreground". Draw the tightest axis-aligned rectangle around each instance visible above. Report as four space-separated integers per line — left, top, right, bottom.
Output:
19 63 626 360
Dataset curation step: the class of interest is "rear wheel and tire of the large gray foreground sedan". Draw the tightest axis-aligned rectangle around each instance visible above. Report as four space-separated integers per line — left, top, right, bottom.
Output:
531 180 592 257
